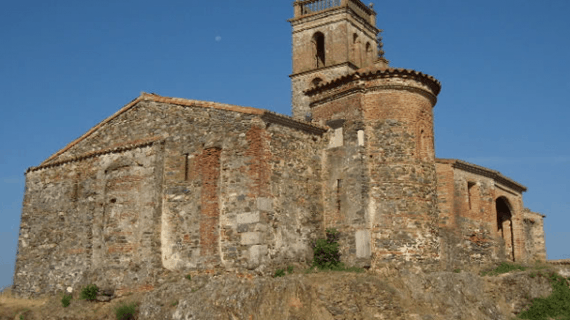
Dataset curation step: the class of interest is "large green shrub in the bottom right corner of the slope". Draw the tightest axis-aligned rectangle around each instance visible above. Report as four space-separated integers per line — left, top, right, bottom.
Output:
518 272 570 320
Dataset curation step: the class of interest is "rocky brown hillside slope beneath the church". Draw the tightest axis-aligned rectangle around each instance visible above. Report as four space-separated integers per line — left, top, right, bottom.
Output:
0 268 570 320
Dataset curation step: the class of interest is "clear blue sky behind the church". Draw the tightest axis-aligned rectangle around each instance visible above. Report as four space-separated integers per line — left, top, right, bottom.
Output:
0 0 570 287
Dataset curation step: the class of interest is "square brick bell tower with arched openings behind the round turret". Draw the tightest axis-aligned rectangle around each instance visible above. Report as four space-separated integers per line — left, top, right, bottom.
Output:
289 0 381 120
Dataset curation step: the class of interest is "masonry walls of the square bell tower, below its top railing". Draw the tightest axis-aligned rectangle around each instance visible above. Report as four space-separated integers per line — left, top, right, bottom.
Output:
290 7 378 119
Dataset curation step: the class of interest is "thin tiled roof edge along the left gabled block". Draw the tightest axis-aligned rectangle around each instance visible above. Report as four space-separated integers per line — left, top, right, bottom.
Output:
38 92 327 168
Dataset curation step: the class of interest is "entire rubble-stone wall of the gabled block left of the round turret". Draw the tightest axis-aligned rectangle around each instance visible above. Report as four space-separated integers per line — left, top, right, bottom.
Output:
14 96 328 295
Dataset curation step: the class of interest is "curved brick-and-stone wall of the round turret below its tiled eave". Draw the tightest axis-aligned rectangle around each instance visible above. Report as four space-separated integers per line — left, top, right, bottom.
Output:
362 85 439 269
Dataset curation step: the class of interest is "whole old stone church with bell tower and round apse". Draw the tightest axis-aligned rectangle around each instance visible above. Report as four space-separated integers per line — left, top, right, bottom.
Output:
14 0 546 295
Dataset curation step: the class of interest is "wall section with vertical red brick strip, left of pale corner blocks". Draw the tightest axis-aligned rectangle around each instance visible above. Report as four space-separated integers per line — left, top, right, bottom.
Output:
156 104 260 270
